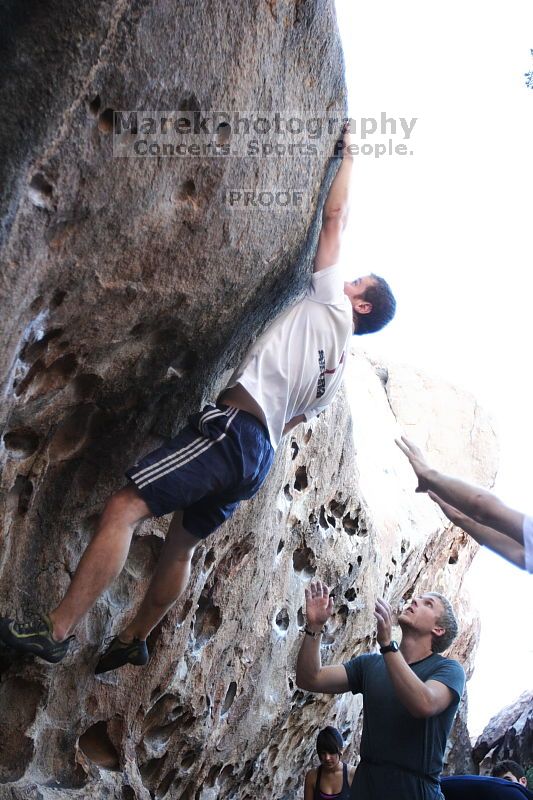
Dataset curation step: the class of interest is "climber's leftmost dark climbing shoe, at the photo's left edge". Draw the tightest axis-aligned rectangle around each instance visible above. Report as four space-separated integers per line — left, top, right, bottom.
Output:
0 614 74 664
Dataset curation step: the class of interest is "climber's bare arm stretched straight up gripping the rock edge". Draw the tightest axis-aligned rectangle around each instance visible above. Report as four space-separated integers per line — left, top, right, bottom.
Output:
313 123 353 272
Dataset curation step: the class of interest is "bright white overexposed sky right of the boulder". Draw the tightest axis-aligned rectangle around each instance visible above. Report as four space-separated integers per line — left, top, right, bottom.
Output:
336 0 533 735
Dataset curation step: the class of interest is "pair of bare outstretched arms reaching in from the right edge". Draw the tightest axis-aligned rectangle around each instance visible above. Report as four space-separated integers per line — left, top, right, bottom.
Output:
396 436 533 573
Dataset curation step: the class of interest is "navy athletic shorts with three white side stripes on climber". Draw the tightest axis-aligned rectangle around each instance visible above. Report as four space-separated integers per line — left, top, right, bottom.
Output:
126 405 274 539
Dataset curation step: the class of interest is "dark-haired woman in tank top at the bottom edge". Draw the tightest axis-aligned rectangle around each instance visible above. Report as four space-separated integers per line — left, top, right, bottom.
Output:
304 725 355 800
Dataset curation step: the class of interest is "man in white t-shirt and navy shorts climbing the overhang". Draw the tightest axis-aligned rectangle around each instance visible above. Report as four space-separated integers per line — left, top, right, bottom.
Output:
0 127 392 673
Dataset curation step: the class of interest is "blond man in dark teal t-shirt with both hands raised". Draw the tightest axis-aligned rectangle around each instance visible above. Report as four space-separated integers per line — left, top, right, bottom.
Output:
296 580 465 800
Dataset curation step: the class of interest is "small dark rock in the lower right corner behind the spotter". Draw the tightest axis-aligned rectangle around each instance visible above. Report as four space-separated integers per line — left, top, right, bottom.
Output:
473 692 533 775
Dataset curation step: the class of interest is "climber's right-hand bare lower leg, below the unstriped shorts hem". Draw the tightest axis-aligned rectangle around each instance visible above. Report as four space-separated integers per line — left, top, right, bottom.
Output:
119 511 200 642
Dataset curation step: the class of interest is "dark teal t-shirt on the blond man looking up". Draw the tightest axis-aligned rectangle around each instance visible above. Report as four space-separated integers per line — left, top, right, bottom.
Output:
344 653 465 800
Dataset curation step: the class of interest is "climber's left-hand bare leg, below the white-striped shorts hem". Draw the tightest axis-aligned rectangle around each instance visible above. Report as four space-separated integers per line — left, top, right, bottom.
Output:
49 486 152 641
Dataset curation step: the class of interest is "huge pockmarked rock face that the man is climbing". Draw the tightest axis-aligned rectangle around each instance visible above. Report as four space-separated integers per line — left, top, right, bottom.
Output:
0 0 495 800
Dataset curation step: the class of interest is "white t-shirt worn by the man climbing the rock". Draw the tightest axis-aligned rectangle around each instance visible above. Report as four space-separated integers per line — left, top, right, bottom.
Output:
227 264 352 448
